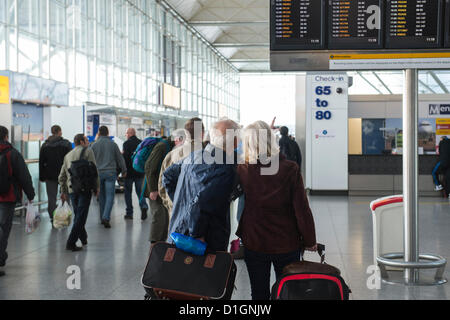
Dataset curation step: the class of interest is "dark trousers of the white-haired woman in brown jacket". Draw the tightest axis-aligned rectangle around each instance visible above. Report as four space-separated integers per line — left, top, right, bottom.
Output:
245 249 301 301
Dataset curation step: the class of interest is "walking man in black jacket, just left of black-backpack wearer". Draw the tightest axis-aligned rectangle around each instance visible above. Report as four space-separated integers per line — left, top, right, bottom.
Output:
39 126 72 226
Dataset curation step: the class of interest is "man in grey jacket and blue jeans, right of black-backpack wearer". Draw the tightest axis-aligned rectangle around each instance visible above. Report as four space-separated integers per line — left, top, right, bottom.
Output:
91 126 127 229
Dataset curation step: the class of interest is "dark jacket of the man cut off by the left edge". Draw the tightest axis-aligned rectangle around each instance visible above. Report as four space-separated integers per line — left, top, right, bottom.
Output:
0 142 35 203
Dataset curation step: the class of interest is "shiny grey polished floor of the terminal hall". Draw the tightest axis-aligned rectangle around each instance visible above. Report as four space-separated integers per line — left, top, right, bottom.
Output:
0 195 450 300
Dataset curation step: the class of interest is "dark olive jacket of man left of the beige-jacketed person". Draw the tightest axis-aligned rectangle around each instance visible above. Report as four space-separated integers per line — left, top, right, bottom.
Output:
144 140 175 198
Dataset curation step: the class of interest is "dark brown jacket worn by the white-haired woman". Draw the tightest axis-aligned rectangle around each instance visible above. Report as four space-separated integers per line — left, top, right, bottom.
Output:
236 155 316 254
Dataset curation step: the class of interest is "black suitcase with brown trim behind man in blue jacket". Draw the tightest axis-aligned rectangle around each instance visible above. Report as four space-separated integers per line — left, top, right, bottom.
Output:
142 242 237 300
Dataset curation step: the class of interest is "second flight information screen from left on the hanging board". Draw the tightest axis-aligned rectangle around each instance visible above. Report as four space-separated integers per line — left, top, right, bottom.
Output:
328 0 384 49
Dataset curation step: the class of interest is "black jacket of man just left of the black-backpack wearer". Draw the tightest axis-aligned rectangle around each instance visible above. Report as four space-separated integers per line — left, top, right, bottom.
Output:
39 136 72 182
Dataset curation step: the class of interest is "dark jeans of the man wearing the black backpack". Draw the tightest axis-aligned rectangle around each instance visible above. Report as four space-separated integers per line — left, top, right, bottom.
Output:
67 193 92 247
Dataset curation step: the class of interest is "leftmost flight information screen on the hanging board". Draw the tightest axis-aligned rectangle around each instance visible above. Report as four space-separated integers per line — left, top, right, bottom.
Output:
270 0 325 50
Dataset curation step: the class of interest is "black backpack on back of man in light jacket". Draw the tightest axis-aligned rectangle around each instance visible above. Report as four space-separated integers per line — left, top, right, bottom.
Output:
69 148 98 194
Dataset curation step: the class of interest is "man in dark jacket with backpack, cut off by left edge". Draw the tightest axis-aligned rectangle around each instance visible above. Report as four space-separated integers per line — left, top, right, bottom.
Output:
0 126 35 277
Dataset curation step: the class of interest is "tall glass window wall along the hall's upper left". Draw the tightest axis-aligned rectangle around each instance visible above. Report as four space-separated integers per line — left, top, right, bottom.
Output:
0 0 240 126
